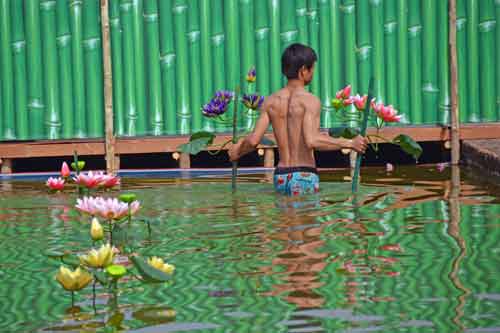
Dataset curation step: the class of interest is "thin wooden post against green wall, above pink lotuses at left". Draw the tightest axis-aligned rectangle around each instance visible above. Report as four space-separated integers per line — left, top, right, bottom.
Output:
101 0 117 174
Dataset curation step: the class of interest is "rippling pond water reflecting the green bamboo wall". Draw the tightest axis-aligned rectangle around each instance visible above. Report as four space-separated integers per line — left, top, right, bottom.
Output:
0 166 500 333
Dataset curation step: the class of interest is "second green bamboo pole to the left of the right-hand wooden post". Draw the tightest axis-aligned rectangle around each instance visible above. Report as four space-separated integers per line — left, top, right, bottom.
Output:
421 0 439 123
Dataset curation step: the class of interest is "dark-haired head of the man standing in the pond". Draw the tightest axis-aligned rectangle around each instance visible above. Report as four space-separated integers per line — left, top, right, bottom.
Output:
281 43 318 85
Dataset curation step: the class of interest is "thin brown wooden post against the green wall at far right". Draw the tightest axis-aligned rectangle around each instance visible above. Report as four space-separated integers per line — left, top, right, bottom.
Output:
448 0 463 165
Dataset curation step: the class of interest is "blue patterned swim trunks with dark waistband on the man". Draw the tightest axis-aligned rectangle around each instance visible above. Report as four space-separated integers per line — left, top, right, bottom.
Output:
274 167 319 196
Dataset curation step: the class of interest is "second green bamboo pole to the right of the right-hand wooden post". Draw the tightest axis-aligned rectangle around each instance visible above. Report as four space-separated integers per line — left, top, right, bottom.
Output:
466 0 481 122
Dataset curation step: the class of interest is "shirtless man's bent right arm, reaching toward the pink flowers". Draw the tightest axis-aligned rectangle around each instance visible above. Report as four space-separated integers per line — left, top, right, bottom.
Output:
303 96 367 153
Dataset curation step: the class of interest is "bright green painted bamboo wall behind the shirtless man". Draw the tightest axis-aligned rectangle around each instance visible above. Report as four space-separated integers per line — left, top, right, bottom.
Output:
0 0 500 141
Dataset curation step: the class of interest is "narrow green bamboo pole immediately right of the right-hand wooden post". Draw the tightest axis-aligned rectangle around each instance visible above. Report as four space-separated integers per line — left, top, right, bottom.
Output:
457 0 469 122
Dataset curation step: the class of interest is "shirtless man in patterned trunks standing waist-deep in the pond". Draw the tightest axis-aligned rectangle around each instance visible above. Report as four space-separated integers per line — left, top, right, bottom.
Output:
229 44 368 195
